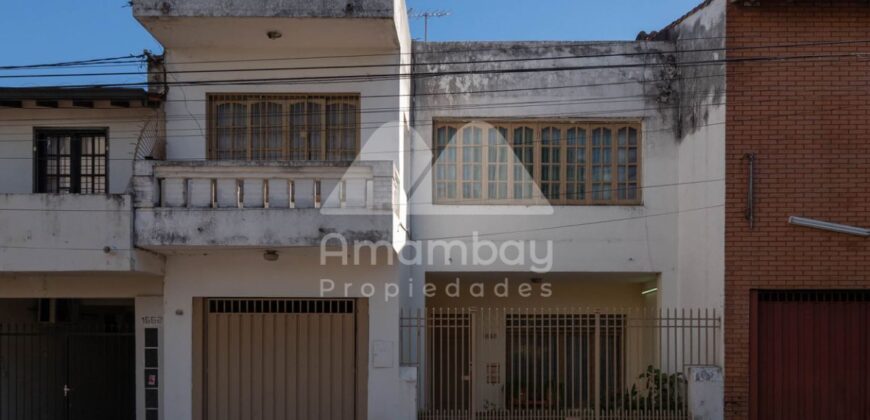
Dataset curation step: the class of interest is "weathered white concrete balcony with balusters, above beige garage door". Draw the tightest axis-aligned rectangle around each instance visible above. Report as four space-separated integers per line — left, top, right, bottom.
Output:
133 160 400 248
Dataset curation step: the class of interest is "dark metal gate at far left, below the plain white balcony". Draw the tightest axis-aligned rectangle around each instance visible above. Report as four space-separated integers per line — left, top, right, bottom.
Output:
0 323 136 420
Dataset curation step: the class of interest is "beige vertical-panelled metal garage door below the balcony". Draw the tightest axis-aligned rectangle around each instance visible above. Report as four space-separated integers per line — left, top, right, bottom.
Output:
194 298 367 420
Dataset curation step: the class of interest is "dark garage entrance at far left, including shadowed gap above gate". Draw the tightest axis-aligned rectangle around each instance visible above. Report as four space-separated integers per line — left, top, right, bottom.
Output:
0 299 136 420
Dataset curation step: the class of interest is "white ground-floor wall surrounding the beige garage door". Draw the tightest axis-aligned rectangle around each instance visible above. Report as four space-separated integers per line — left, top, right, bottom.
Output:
163 249 403 419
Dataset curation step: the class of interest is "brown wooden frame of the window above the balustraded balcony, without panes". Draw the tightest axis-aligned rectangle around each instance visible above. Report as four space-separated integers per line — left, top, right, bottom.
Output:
206 93 361 162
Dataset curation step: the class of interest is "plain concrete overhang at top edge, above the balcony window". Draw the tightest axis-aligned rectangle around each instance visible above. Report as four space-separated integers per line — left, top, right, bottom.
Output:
131 0 407 49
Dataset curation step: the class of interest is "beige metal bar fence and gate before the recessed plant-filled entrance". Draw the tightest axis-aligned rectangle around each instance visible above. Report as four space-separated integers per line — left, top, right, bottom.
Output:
400 307 721 420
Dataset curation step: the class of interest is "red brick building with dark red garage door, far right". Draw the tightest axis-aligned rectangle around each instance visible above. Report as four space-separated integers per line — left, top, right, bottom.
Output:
725 0 870 420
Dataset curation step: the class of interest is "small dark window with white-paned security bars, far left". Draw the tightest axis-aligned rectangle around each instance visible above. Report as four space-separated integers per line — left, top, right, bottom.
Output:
34 129 109 194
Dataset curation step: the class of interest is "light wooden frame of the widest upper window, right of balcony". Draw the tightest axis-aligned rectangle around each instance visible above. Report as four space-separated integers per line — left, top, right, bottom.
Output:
432 119 643 206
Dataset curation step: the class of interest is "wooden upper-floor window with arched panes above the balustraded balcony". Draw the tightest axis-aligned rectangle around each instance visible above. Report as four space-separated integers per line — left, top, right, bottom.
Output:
208 94 360 161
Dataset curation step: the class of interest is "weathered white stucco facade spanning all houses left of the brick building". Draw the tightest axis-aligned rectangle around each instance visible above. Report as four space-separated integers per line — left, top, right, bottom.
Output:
0 0 725 420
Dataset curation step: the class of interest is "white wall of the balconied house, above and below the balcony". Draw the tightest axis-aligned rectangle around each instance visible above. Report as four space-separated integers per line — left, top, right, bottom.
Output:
152 13 418 419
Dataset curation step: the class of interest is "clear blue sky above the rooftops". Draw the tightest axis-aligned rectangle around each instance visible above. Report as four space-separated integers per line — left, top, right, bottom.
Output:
0 0 700 86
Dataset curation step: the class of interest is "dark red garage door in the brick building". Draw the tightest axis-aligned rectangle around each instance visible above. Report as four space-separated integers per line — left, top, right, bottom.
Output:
750 290 870 420
